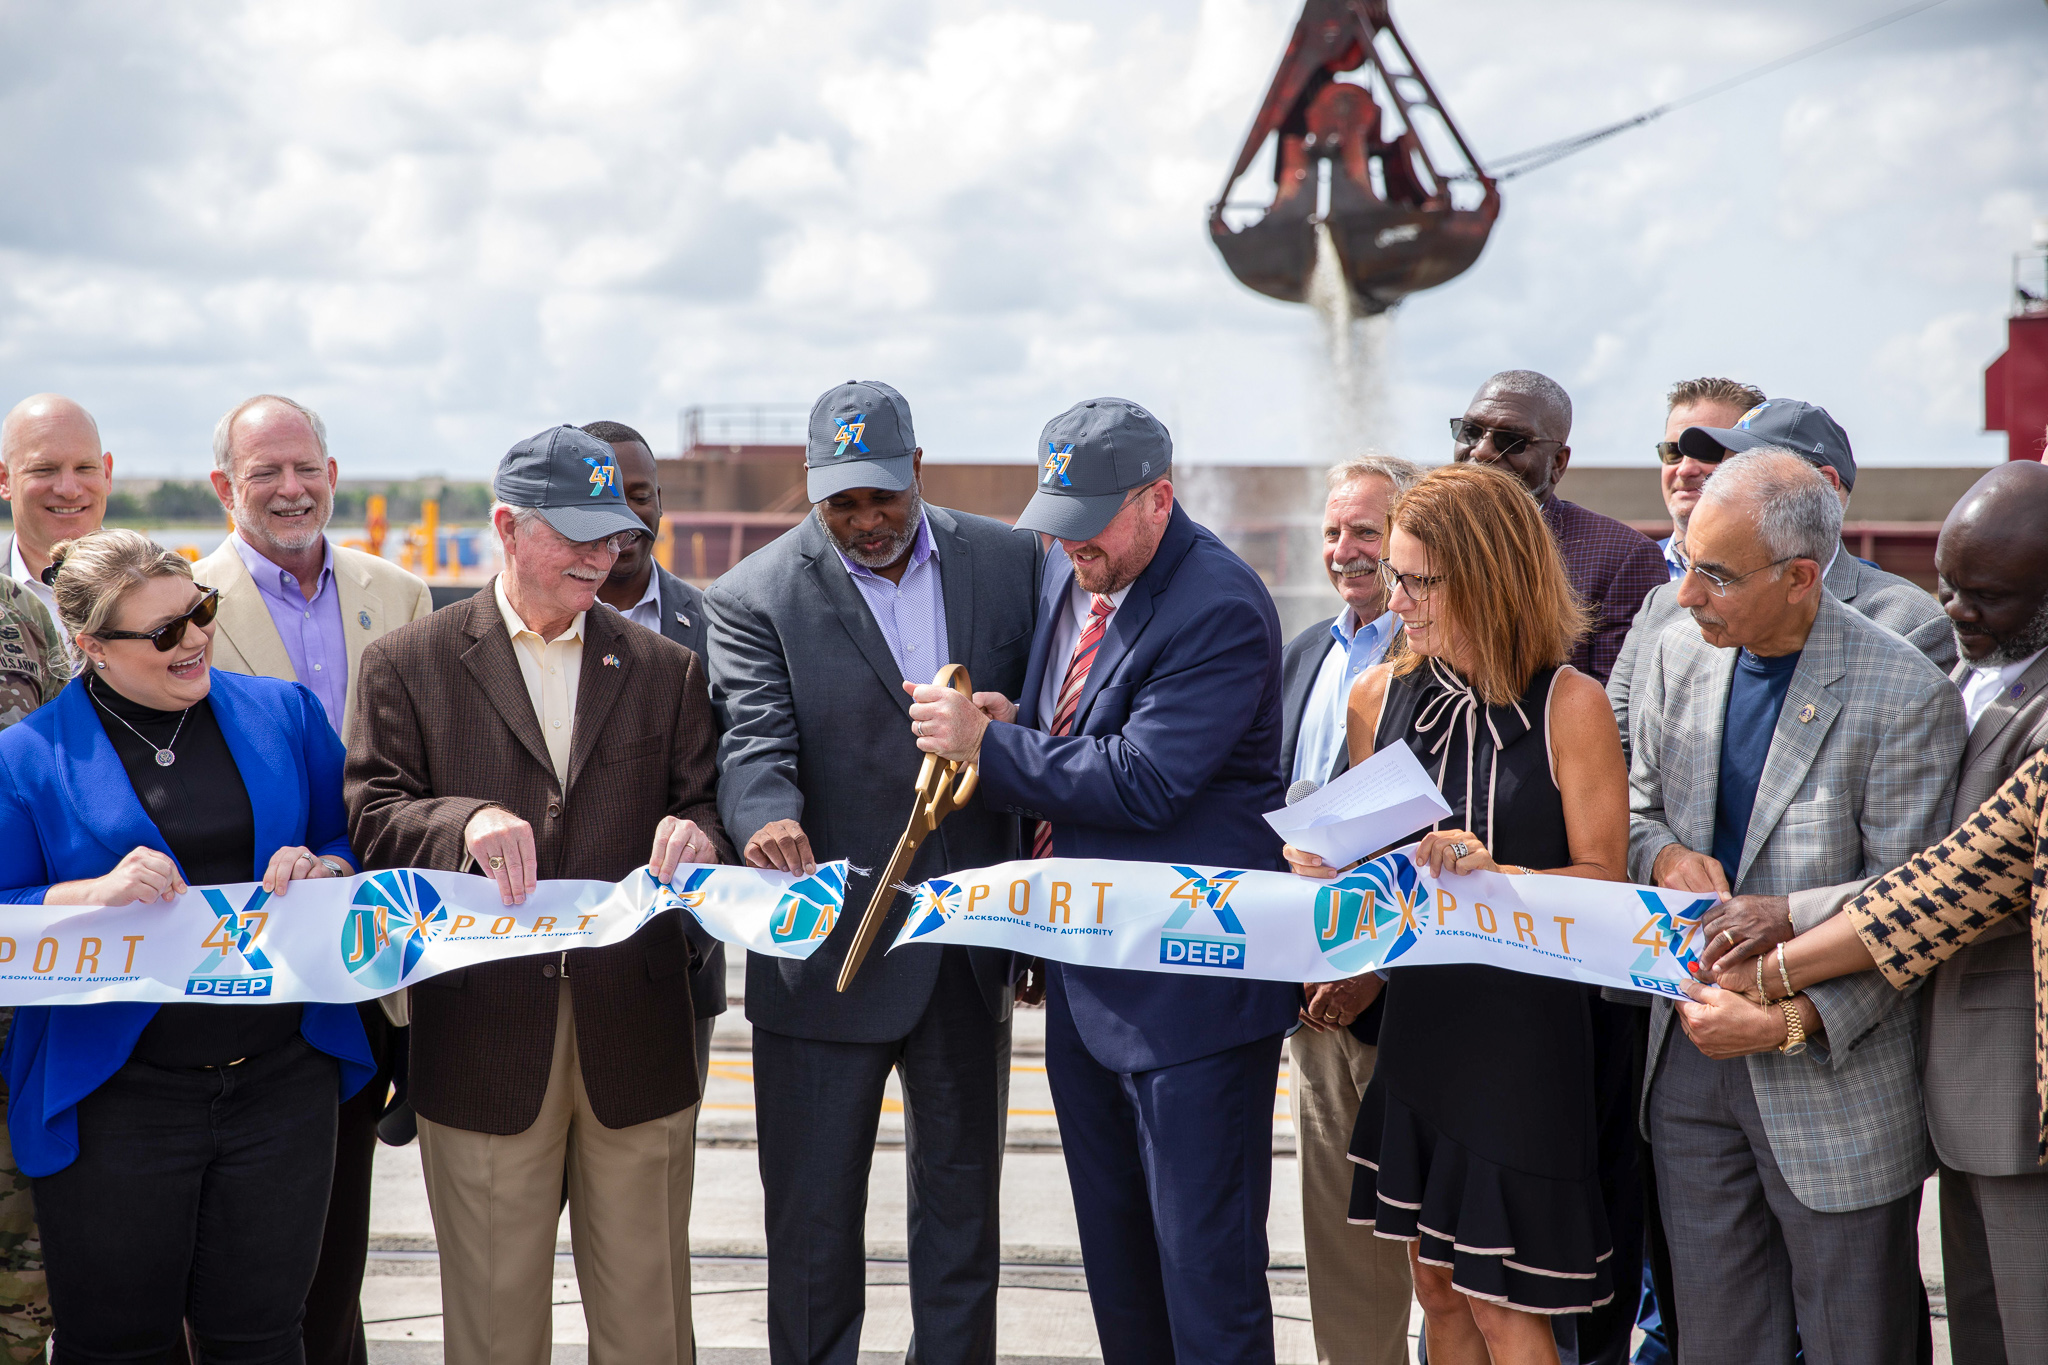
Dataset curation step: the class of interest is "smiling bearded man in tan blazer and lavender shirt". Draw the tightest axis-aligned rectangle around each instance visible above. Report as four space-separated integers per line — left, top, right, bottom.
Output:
193 393 434 1365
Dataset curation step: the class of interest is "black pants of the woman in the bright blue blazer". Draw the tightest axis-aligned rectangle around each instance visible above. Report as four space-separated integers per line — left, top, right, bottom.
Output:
35 1038 340 1365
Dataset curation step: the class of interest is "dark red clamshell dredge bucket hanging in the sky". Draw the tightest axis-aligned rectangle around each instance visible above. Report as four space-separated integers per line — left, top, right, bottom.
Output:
1208 0 1501 313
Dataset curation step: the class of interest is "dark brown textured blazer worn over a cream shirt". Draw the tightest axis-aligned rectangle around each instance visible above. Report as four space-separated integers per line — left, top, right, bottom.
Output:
344 587 733 1134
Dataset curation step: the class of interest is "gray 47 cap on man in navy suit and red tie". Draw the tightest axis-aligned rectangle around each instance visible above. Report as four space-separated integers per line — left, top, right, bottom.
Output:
1018 399 1174 540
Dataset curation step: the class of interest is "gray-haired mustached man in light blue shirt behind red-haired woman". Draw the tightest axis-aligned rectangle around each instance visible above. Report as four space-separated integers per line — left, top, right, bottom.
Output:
1280 454 1421 1365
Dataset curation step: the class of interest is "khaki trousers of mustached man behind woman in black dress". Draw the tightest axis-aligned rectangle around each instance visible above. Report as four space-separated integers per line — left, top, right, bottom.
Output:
1288 1027 1415 1365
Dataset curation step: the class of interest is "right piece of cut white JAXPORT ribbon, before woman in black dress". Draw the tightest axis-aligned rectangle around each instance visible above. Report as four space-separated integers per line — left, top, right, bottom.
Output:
891 849 1718 997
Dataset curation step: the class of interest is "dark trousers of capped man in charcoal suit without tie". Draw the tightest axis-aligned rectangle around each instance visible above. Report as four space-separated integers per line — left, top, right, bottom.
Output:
754 948 1010 1365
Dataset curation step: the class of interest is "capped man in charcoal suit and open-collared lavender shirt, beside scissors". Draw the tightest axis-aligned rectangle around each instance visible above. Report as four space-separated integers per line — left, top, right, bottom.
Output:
705 381 1040 1365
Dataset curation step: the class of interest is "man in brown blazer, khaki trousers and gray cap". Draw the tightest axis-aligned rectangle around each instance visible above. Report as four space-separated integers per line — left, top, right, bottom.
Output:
346 426 733 1365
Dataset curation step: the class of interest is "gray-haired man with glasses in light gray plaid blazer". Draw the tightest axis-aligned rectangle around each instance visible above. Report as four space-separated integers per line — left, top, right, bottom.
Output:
1628 448 1964 1365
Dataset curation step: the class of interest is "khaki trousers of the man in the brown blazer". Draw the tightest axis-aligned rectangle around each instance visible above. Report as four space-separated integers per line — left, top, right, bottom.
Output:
420 980 696 1365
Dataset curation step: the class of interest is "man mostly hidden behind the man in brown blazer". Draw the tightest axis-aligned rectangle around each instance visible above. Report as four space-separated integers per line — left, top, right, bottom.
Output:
582 422 725 1087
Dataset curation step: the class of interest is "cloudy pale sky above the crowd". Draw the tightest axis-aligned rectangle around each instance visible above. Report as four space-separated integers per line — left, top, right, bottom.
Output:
0 0 2048 477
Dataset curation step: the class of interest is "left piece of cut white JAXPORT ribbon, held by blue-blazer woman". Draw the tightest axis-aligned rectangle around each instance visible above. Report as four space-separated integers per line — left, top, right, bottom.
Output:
0 862 846 1005
